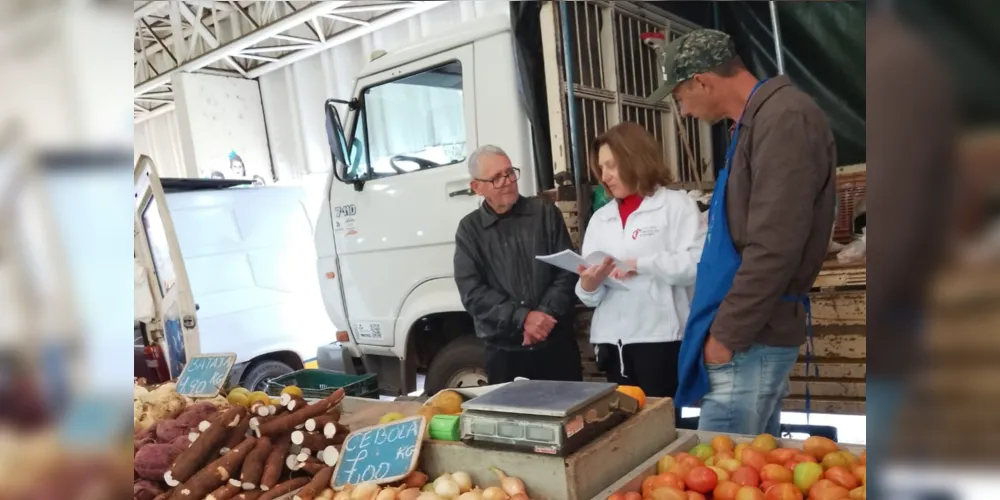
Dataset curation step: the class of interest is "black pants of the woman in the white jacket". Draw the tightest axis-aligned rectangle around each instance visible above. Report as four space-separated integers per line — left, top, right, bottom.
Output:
597 341 681 421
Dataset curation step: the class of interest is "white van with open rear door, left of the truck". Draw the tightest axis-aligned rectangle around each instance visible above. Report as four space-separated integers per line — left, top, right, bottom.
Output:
135 157 336 388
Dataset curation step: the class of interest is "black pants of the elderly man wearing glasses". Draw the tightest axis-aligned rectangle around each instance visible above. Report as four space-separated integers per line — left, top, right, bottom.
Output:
486 335 583 384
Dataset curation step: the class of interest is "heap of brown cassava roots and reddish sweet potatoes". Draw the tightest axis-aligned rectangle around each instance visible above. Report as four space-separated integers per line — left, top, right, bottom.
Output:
133 389 350 500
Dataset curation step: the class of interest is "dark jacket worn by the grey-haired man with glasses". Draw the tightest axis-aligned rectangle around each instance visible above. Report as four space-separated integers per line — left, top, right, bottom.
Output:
455 193 578 350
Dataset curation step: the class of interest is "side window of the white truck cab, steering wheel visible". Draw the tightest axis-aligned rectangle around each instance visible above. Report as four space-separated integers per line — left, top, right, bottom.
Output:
345 61 466 181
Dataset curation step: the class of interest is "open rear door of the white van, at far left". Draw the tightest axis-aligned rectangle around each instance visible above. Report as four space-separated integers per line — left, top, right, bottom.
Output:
134 155 201 377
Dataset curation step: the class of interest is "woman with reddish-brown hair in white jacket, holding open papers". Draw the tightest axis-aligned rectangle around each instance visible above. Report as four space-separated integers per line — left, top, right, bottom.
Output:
576 123 706 397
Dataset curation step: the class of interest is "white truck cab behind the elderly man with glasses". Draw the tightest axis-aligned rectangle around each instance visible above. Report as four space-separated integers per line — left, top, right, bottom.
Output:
316 16 538 394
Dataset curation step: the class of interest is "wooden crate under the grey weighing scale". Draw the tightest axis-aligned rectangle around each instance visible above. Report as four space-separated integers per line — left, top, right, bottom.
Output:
420 398 677 500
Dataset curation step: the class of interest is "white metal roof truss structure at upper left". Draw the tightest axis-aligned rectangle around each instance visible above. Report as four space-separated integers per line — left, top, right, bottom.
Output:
133 0 447 123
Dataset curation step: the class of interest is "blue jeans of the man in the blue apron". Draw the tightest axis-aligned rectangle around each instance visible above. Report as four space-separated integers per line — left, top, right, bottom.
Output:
698 344 799 437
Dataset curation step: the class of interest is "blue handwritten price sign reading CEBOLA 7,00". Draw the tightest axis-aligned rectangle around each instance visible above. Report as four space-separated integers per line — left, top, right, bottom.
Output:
333 416 427 489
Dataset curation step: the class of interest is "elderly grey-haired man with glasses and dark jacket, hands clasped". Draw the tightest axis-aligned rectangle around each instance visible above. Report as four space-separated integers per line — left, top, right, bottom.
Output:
455 146 583 384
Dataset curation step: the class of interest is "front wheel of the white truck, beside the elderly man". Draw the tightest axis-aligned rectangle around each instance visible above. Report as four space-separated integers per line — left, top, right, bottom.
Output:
424 335 488 394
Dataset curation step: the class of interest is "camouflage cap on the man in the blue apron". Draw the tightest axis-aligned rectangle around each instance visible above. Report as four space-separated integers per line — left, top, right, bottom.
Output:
649 29 736 103
